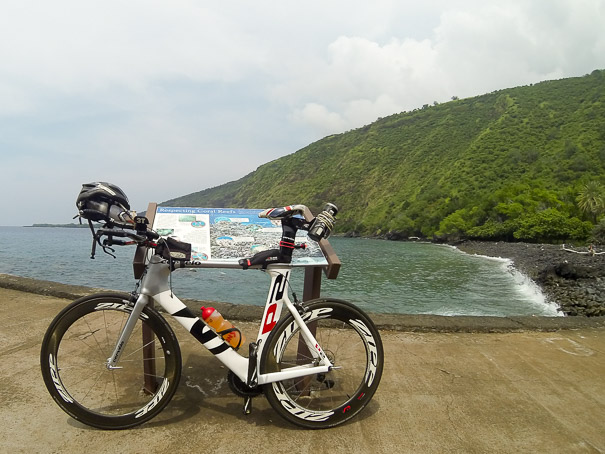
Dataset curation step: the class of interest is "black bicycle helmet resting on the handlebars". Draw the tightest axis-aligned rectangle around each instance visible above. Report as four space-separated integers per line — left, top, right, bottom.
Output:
76 182 130 222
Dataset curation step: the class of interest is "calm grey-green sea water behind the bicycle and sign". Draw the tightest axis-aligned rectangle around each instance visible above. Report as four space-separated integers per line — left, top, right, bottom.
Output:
0 227 558 316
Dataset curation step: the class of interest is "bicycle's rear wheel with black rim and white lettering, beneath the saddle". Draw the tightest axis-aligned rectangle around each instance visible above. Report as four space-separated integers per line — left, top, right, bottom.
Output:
260 299 384 429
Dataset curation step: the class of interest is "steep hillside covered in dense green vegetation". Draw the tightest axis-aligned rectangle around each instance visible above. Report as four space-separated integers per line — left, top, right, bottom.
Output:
164 70 605 242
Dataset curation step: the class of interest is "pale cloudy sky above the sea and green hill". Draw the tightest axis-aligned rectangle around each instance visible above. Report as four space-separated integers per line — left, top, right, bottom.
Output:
0 0 605 225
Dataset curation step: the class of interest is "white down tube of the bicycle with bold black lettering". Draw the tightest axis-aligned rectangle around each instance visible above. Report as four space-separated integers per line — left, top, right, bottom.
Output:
153 290 248 383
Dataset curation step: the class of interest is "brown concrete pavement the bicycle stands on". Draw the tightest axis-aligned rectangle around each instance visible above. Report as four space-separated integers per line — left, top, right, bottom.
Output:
0 282 605 453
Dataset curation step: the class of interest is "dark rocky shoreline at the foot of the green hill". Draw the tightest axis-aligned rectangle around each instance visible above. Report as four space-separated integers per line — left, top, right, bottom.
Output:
454 241 605 317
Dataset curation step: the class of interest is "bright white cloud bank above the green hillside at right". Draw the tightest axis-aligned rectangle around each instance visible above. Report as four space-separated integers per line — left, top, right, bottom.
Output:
275 0 605 133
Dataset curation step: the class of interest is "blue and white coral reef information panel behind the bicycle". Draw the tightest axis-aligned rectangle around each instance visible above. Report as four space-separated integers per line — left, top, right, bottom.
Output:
153 207 327 266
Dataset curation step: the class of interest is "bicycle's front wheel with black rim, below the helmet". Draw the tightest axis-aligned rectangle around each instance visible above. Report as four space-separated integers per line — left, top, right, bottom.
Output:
40 293 182 429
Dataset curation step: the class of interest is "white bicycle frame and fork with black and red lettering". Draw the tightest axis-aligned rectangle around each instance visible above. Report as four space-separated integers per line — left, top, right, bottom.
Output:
107 255 333 386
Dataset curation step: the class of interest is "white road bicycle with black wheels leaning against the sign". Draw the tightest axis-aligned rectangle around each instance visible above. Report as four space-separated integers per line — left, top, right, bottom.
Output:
40 196 384 429
